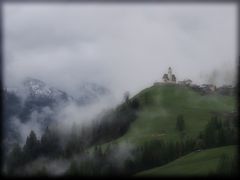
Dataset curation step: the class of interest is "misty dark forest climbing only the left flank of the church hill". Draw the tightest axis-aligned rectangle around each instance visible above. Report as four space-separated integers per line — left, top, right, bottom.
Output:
65 97 139 157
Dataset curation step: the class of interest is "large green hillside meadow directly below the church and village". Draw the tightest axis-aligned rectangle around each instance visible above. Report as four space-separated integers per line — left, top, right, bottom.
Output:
101 84 236 147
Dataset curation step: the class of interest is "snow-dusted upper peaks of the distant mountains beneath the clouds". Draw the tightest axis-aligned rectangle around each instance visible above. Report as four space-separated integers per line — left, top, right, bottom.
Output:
4 78 111 105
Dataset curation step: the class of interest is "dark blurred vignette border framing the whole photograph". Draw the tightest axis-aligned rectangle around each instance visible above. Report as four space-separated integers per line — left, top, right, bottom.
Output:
0 0 240 178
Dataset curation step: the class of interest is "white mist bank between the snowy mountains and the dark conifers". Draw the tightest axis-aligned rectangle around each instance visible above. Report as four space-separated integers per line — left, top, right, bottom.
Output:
7 90 117 146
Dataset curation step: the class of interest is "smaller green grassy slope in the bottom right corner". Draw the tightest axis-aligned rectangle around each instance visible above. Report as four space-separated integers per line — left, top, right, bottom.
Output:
136 146 237 176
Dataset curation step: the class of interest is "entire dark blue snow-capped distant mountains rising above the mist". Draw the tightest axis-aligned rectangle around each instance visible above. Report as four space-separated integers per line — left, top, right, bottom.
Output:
3 78 111 147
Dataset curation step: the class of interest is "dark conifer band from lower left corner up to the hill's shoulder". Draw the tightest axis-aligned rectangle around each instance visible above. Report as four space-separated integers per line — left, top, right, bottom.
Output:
6 97 139 172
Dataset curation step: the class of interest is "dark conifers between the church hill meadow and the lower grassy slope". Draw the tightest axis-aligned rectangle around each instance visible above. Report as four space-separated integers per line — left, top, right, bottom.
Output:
64 116 238 176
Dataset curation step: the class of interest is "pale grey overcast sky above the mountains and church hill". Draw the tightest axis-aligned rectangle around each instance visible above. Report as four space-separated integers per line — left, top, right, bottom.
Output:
4 3 237 98
